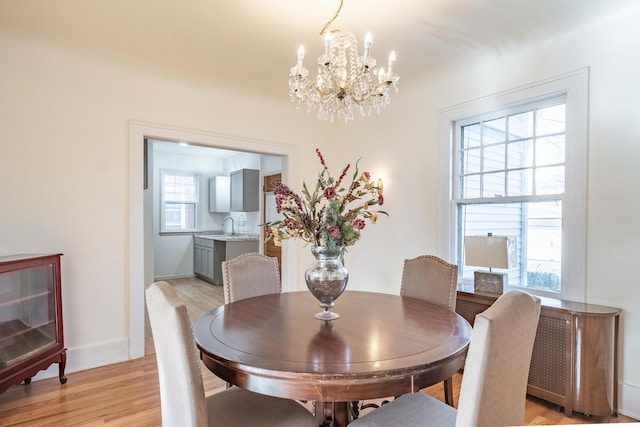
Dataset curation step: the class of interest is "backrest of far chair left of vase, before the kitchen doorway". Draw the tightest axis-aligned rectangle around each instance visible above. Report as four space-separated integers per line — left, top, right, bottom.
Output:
222 253 282 304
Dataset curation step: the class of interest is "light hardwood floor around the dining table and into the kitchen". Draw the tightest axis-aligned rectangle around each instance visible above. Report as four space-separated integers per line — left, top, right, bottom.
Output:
0 279 635 427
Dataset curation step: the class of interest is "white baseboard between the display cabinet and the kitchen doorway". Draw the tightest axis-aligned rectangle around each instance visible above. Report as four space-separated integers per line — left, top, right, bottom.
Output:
32 340 129 381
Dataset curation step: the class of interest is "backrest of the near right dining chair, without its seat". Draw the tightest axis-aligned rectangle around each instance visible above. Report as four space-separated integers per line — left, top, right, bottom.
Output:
456 291 540 427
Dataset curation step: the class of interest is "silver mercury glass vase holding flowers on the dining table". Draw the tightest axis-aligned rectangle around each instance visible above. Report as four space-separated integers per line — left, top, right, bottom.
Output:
304 246 349 320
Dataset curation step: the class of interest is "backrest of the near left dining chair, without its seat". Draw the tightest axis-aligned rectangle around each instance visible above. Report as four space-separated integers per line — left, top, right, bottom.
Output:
145 282 208 427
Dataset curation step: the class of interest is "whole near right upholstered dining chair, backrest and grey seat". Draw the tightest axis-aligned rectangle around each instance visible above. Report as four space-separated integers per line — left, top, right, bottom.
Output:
349 291 540 427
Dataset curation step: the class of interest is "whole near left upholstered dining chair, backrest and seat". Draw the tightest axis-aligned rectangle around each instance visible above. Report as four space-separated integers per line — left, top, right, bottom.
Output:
145 282 316 427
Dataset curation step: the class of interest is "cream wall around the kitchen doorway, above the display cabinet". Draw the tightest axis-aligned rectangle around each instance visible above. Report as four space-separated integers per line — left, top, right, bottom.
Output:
0 37 330 372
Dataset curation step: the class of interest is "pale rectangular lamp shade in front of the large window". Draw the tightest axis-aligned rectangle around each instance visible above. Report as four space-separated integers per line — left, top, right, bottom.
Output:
464 236 516 268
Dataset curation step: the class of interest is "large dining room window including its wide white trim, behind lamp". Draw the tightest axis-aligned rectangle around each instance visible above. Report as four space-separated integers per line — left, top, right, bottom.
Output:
441 70 588 301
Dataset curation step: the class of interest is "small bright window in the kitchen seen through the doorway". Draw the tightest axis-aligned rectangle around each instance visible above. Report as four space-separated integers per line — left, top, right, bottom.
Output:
160 170 198 232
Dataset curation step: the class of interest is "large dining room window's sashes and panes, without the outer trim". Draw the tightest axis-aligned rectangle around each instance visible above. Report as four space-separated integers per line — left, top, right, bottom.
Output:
454 100 566 292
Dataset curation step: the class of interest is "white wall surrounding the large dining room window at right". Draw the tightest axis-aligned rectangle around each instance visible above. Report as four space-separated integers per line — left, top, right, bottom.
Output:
340 2 640 418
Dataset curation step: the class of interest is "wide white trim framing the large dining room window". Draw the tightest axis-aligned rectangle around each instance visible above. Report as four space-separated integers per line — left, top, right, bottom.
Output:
438 67 589 302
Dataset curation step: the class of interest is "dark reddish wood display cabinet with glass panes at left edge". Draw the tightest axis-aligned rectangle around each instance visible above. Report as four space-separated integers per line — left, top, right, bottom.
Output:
0 254 67 393
